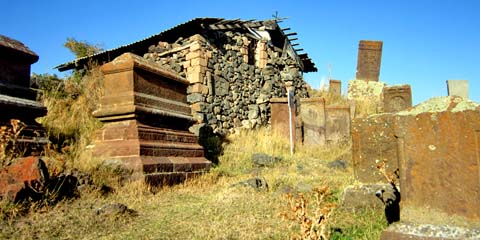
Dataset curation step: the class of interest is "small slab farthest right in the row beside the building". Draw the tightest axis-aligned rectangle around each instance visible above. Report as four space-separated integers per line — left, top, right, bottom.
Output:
325 105 350 144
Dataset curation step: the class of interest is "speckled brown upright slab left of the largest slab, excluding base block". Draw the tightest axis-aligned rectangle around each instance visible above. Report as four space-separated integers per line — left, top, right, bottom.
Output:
352 113 398 184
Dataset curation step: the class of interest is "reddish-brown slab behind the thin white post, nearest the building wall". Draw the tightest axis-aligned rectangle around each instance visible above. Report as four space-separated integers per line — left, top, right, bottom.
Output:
270 98 297 142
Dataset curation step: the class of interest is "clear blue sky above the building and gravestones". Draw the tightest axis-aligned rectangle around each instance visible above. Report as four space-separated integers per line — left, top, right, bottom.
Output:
0 0 480 104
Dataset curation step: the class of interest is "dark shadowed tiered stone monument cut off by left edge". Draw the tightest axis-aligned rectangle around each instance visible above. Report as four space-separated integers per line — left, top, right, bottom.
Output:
0 35 47 155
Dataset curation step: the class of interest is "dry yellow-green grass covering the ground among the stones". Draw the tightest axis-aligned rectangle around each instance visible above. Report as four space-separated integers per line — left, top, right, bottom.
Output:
0 129 386 239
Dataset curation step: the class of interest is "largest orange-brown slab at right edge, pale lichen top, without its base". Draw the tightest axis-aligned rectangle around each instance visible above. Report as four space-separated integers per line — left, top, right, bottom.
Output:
395 97 480 221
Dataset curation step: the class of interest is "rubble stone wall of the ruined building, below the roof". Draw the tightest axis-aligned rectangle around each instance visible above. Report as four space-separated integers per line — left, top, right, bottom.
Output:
144 31 308 134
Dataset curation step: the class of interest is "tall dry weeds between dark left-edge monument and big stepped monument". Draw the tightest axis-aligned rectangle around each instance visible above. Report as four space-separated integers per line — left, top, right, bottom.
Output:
39 67 103 169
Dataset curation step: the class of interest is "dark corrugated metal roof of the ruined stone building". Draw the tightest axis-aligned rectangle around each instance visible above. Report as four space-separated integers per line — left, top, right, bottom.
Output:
55 18 317 72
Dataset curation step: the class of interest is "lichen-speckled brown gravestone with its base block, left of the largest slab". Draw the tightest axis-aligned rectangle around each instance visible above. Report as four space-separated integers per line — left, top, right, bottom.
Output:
344 113 398 209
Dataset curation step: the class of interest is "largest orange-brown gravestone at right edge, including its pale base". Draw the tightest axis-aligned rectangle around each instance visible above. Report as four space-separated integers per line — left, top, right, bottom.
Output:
382 96 480 239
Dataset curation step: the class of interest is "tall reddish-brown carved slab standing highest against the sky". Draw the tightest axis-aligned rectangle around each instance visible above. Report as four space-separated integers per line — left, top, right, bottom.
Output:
356 40 383 82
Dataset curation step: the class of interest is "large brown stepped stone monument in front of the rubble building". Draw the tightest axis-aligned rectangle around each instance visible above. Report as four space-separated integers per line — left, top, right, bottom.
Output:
94 53 210 184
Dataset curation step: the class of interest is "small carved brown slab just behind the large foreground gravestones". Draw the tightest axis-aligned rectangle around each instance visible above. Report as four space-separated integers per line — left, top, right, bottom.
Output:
383 85 412 112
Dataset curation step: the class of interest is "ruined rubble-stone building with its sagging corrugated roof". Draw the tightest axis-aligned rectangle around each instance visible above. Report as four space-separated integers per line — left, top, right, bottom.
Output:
57 18 317 134
